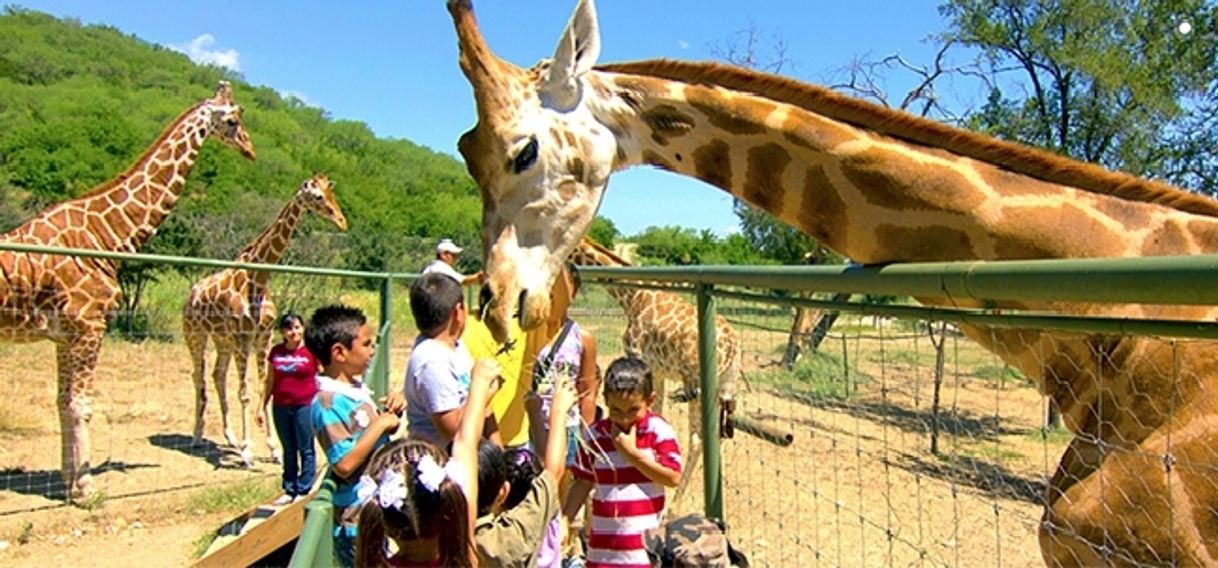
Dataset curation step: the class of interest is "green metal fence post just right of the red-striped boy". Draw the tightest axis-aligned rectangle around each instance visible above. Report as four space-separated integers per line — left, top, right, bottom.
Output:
695 284 723 519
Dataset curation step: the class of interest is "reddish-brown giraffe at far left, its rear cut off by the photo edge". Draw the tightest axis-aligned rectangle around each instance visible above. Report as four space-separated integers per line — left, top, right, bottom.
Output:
0 82 255 500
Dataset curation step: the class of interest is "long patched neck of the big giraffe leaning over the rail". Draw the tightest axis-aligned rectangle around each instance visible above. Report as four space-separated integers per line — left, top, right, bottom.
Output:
588 63 1218 263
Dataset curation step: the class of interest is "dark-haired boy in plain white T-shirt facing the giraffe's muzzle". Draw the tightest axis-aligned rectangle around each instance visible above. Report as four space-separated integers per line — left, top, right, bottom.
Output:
404 272 499 447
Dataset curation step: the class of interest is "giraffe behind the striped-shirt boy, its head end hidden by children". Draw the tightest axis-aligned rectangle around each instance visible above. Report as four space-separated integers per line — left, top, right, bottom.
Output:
570 238 742 502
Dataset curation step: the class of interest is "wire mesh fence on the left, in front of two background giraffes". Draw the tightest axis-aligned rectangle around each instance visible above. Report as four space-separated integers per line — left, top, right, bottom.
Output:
0 258 413 518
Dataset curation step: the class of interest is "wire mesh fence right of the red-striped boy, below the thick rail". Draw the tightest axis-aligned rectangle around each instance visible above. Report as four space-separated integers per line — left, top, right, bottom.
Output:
575 277 1214 566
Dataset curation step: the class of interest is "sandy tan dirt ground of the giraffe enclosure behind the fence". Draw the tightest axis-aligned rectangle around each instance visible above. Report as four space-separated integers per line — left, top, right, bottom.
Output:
0 312 1061 566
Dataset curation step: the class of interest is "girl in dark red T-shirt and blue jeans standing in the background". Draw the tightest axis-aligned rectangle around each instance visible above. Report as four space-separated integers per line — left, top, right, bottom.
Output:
253 312 320 506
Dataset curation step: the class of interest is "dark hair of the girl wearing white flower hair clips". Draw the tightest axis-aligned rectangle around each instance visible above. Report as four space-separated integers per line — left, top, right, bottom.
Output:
356 439 475 567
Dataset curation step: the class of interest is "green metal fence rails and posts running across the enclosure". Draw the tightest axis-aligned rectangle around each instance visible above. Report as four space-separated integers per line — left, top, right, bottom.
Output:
7 243 1218 567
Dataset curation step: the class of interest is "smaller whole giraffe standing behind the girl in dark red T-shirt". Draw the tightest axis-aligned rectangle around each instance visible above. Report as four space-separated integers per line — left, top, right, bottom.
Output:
181 173 347 467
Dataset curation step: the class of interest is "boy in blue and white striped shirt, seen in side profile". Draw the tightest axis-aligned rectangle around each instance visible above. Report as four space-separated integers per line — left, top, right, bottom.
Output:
305 306 406 566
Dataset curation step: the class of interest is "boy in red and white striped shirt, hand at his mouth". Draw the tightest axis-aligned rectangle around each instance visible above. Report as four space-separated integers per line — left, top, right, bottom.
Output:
563 357 681 567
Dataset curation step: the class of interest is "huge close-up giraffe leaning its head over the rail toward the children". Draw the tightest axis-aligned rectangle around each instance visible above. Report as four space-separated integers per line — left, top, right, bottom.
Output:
448 0 1218 566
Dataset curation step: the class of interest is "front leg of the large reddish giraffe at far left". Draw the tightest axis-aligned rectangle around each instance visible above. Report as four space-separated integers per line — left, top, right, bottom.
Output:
56 329 102 501
